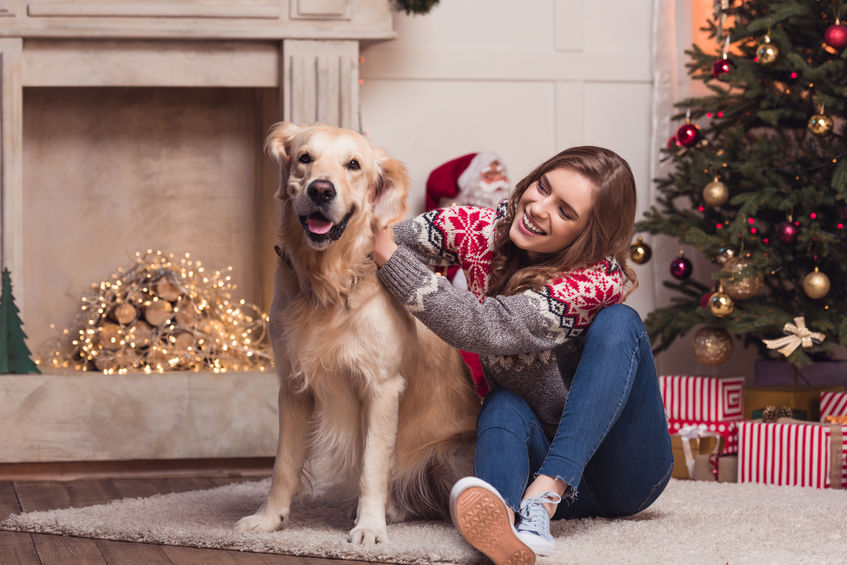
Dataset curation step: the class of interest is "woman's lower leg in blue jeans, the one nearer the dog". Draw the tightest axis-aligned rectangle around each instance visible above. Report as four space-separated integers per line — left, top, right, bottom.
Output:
474 389 549 512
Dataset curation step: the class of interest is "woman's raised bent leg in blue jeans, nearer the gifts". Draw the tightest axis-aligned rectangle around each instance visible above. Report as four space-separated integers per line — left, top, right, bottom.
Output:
538 304 673 518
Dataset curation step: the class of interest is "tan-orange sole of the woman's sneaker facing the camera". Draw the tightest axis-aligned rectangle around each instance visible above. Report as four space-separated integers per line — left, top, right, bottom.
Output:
456 487 535 565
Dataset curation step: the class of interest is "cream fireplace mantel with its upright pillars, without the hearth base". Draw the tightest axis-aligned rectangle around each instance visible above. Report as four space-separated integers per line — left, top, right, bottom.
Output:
0 0 394 308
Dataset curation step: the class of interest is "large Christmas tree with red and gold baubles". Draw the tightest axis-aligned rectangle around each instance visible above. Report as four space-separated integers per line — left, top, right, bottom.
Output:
632 0 847 366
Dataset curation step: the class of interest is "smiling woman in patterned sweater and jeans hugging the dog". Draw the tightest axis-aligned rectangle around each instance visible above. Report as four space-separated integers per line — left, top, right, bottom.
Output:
373 146 673 563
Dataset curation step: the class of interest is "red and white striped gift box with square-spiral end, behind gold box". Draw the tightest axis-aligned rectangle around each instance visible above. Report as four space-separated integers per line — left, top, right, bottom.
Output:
659 375 744 422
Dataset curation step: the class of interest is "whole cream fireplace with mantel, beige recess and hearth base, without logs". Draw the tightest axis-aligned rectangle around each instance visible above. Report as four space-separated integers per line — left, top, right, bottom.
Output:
0 0 394 461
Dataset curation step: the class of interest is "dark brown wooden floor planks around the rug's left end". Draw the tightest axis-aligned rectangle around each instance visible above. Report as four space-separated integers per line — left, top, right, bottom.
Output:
0 477 378 565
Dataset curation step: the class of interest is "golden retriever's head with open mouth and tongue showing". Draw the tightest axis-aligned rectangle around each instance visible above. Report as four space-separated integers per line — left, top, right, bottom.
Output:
265 122 409 250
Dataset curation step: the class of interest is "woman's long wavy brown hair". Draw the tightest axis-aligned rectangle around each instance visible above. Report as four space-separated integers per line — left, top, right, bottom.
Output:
487 145 638 296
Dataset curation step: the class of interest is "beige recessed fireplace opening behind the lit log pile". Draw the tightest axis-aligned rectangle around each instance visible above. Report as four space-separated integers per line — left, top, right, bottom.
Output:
22 87 279 364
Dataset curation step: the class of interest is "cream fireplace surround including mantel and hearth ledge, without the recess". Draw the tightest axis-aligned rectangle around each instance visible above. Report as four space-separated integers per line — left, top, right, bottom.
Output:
0 0 394 463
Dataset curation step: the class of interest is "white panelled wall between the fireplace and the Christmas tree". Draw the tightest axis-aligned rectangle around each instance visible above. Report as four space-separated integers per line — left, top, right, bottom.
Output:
360 0 653 316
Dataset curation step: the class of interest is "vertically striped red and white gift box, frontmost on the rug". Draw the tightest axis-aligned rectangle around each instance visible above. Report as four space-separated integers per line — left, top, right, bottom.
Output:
738 421 847 488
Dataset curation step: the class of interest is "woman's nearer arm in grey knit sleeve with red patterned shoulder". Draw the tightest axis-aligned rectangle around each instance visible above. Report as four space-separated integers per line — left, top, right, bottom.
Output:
379 246 622 355
